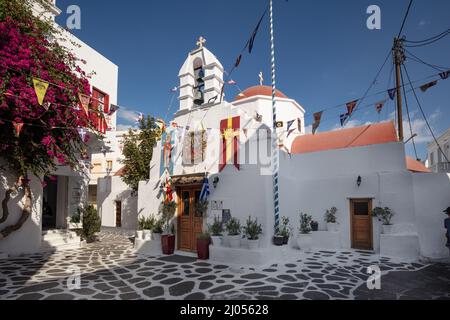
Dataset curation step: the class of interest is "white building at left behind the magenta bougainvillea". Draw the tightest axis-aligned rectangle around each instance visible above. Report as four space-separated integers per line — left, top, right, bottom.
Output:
0 0 118 255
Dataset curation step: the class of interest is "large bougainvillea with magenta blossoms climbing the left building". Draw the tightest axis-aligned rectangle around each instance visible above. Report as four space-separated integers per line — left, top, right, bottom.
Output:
0 0 95 238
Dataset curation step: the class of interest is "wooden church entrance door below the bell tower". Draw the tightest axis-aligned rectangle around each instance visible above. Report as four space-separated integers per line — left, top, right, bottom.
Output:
178 187 203 252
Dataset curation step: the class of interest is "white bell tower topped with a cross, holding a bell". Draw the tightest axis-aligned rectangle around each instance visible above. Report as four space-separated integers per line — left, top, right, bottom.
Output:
178 37 224 111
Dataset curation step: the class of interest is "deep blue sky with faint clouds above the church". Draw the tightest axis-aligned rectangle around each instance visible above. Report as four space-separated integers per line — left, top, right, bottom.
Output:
57 0 450 159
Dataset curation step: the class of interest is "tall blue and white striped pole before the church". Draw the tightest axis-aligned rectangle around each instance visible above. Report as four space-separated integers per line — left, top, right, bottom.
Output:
269 0 280 233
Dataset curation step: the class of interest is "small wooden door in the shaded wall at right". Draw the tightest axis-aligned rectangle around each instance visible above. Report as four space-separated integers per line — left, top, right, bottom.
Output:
350 199 373 250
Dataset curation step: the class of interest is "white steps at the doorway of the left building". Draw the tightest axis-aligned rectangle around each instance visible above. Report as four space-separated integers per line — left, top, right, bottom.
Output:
41 230 81 251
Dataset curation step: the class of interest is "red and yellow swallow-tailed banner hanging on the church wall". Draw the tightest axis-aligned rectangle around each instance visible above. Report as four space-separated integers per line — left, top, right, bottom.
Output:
219 117 241 172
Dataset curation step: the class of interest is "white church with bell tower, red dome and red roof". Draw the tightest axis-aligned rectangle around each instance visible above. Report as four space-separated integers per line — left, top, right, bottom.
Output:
123 41 450 264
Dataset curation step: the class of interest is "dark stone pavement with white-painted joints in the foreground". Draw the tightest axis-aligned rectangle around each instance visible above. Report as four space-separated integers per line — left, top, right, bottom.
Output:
0 232 450 300
